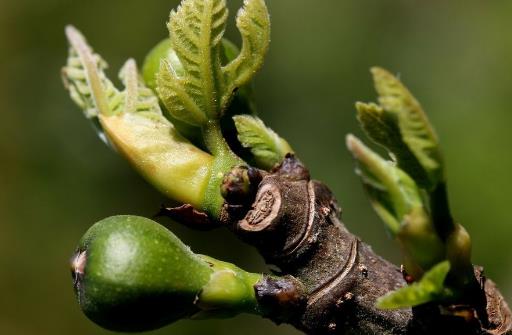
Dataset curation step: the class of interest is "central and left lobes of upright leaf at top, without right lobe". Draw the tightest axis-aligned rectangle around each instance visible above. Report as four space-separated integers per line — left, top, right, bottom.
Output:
157 0 228 126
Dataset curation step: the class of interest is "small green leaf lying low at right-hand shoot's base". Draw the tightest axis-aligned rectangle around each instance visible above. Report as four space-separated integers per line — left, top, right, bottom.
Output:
376 261 452 309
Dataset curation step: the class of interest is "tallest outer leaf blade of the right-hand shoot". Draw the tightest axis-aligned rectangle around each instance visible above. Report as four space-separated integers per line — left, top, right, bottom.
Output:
371 67 444 191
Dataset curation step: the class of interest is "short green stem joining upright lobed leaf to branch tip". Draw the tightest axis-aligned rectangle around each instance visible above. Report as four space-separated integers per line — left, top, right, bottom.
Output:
203 120 245 219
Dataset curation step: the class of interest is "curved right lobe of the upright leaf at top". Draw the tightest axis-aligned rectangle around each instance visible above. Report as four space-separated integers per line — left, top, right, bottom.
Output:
221 0 270 109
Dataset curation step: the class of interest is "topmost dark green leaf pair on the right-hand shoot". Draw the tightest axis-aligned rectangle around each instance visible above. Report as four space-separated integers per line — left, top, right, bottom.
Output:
356 68 444 191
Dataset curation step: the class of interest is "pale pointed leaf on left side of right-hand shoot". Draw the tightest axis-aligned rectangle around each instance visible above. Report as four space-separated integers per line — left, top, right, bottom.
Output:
347 135 422 234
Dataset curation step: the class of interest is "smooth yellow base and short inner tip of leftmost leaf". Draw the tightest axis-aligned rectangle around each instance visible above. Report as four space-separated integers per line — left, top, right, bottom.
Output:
100 61 213 208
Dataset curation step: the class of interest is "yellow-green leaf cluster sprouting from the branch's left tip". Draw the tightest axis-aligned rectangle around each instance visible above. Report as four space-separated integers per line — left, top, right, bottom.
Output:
63 0 291 217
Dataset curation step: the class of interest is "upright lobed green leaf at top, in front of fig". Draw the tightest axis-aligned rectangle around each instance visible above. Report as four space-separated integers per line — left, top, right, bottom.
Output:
157 0 270 127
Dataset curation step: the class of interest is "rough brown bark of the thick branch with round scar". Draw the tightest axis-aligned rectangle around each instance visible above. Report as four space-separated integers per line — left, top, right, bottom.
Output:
221 156 512 335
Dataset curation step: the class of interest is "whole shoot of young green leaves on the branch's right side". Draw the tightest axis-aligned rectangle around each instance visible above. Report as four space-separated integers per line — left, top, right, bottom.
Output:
347 68 471 308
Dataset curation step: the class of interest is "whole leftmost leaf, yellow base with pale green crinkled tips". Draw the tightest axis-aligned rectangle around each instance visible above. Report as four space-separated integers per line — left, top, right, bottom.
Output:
63 27 213 208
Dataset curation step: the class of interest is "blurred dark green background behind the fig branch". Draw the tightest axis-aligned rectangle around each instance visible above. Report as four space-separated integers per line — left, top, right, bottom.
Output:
0 0 512 335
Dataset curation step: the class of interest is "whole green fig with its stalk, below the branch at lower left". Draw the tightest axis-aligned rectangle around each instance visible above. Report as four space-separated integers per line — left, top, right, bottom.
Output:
71 216 262 332
